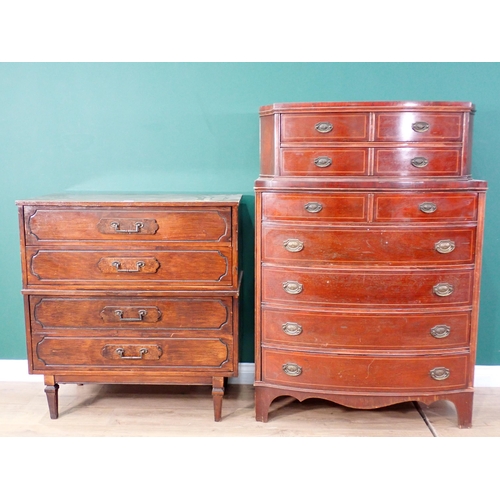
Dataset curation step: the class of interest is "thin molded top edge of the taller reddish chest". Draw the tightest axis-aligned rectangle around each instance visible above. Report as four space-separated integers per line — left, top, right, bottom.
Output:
259 101 475 115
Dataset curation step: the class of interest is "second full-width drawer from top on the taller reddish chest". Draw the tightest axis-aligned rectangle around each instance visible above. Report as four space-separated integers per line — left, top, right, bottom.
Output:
262 266 473 307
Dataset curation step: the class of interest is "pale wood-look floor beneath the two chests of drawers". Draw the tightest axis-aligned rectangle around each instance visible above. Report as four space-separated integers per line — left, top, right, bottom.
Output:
0 382 500 438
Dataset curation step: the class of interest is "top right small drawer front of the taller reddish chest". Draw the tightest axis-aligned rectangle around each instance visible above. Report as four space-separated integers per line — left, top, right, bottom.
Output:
375 112 463 142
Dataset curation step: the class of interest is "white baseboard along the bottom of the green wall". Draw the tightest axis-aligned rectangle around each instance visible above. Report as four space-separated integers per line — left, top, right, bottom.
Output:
0 359 500 387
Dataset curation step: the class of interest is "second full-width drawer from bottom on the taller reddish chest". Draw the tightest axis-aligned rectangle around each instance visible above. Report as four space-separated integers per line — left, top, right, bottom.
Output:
262 308 470 351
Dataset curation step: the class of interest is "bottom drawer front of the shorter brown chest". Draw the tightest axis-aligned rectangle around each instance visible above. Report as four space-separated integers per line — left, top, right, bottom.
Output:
33 335 232 370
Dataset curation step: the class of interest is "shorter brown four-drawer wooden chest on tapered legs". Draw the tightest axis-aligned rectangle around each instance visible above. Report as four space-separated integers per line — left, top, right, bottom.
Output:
17 194 241 421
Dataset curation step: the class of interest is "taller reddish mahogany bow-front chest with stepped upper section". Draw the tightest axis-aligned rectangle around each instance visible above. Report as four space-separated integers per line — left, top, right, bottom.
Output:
255 102 487 427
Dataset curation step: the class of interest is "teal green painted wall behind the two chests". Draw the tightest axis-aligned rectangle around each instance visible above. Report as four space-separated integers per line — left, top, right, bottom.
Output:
0 63 500 365
